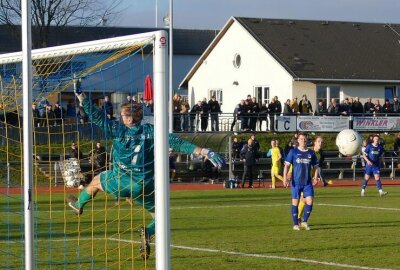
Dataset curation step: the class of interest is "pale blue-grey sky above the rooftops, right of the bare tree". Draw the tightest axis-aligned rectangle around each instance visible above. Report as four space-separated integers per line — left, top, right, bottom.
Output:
109 0 400 29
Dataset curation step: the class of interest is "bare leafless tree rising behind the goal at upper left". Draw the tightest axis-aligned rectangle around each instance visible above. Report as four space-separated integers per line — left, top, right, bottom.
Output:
0 0 122 48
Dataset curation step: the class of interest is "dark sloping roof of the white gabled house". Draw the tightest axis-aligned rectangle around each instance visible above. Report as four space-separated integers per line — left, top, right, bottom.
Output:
234 18 400 82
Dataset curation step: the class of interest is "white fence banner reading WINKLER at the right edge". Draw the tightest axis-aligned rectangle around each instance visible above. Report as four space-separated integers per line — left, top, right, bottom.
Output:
353 117 400 131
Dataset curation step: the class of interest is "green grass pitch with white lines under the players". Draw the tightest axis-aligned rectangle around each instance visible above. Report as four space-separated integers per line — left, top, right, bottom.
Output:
0 187 400 270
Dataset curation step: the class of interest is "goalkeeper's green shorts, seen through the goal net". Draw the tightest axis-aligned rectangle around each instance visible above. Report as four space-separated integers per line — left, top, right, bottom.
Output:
100 170 155 213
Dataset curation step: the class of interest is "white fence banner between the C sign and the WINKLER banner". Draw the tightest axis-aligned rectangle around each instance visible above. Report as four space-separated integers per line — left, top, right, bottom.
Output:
297 116 349 132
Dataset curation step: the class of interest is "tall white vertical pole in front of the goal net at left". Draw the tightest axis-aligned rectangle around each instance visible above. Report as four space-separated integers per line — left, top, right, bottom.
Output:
21 0 34 270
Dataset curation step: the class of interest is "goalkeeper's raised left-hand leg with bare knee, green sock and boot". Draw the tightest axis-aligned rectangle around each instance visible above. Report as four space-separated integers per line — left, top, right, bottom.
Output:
67 171 107 215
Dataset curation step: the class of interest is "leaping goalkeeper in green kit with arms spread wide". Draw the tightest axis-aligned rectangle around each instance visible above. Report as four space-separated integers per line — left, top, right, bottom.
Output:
67 80 225 258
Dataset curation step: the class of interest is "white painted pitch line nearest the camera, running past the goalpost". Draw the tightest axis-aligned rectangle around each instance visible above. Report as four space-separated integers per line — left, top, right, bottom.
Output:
0 233 391 270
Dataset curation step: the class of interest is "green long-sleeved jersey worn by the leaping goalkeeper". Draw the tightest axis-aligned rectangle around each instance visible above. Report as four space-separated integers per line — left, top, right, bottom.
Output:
82 98 196 181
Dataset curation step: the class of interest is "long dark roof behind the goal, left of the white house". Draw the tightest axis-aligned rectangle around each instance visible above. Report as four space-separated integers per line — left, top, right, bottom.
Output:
0 25 218 55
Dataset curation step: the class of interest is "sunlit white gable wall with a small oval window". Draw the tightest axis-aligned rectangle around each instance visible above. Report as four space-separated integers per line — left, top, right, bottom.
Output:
188 22 292 113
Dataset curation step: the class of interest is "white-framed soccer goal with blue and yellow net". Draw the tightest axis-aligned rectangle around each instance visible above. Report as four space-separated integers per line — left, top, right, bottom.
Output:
0 31 169 269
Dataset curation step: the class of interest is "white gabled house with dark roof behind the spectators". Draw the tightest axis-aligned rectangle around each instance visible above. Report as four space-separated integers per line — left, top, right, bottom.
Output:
180 17 400 113
